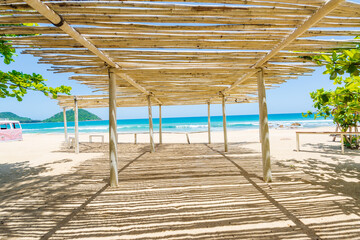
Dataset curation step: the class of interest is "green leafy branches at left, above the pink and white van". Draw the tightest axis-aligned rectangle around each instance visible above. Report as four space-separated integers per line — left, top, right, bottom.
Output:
0 24 71 101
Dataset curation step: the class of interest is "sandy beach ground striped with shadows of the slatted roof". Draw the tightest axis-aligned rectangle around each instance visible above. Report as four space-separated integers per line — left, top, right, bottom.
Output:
0 128 360 239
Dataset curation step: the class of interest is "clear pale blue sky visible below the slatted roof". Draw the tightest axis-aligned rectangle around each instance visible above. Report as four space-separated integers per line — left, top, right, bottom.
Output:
0 49 334 120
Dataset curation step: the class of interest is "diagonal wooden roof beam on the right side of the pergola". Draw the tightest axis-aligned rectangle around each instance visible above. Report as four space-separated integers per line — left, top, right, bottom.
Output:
223 0 345 93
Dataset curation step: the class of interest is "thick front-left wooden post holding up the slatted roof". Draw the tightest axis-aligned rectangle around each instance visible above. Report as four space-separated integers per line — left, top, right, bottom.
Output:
108 68 119 187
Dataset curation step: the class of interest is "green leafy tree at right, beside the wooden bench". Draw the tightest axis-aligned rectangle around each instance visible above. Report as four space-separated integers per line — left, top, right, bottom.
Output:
305 38 360 148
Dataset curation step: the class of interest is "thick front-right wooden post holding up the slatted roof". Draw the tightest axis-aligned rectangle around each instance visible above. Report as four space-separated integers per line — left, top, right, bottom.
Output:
257 68 272 182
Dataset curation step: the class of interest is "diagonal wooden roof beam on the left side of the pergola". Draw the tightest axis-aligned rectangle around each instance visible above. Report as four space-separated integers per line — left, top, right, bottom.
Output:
25 0 162 104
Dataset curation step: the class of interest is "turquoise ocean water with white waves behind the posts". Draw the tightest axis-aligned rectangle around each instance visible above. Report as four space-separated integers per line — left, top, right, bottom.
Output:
22 113 334 133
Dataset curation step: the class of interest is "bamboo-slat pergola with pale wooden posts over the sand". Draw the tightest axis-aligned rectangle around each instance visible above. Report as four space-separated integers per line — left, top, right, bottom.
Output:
0 0 360 185
